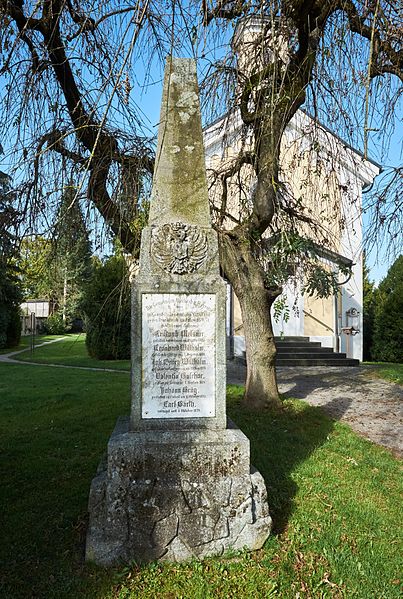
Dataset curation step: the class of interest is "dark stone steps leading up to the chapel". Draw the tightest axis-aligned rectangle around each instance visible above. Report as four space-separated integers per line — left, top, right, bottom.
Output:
275 337 360 366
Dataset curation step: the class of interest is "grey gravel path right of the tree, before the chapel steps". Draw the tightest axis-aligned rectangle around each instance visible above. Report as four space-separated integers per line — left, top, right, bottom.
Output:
228 362 403 458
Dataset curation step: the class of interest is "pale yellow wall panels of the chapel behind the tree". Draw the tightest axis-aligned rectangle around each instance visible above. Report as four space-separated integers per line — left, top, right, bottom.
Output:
207 123 343 336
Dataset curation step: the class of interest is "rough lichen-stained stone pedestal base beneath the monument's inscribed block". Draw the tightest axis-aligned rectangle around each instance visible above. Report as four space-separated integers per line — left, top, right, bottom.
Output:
86 419 271 565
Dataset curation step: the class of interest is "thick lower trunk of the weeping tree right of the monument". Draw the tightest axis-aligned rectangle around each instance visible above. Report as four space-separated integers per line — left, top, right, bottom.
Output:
220 235 281 409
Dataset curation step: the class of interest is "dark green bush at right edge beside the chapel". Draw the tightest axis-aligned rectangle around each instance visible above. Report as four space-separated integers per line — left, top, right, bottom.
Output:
371 255 403 363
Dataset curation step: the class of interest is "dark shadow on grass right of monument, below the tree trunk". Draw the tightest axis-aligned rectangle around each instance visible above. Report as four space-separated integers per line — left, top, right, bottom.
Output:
228 386 348 534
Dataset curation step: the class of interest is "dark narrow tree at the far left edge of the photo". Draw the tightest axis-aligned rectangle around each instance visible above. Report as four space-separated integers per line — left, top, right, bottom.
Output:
0 171 22 348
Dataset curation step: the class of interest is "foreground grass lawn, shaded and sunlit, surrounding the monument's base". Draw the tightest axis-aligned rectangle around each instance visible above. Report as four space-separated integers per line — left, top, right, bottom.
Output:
0 358 403 599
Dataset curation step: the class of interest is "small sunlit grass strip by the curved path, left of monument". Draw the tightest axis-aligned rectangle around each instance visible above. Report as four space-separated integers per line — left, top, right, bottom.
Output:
11 334 130 371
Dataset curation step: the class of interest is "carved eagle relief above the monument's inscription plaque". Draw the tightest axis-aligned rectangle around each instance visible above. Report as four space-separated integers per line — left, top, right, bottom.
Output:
151 222 207 275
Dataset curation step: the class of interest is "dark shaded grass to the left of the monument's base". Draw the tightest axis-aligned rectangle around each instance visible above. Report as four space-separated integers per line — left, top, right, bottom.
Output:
0 364 130 599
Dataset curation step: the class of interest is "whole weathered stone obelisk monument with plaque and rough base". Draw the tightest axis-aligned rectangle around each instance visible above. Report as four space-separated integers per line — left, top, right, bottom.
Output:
86 59 271 565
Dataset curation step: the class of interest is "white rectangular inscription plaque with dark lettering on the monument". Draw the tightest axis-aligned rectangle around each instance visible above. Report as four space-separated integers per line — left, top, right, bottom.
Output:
142 293 216 418
